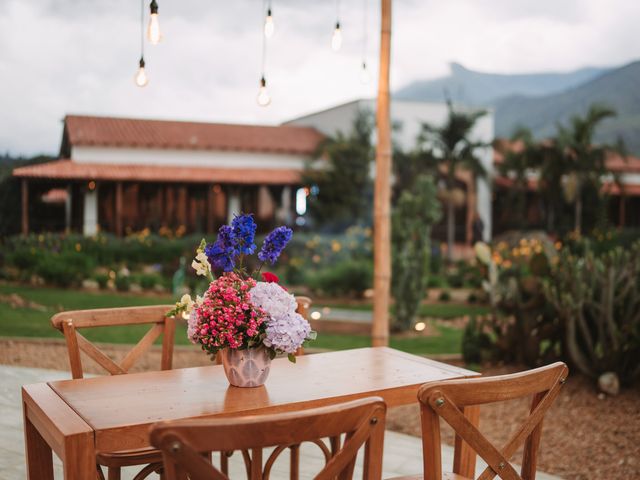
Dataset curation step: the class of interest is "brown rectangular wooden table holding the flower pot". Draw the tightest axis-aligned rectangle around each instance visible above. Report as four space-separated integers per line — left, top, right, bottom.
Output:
22 348 477 480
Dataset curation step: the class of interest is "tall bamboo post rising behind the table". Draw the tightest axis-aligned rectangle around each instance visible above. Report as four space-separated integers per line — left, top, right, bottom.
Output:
371 0 391 347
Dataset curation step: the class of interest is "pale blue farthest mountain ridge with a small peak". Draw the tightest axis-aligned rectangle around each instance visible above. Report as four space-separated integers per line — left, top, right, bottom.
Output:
394 63 611 105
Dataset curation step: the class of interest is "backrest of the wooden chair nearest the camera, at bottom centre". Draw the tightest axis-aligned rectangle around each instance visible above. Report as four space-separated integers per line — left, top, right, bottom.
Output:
151 397 386 480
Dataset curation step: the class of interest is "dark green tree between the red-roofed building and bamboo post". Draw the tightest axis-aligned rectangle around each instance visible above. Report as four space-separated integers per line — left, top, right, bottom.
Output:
303 111 374 230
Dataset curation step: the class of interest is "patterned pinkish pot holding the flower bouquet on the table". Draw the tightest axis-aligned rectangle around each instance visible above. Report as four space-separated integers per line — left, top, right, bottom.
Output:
222 347 271 387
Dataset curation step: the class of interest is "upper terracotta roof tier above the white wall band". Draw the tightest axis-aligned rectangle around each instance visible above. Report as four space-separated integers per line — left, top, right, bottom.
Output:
65 115 323 155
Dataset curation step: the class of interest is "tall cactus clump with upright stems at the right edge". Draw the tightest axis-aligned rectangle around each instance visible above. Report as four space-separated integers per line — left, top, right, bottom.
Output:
544 242 640 384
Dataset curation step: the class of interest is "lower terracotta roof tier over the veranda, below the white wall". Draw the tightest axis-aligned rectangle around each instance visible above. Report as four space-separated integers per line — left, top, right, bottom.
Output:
13 160 301 185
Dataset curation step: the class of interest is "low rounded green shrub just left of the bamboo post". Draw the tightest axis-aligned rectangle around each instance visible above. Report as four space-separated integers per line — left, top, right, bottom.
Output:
310 260 373 297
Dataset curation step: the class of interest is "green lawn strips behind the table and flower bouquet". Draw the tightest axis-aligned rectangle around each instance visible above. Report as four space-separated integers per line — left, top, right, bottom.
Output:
0 285 462 354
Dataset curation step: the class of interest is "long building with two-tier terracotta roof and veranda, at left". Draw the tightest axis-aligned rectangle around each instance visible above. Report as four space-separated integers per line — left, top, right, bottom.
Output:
13 115 322 235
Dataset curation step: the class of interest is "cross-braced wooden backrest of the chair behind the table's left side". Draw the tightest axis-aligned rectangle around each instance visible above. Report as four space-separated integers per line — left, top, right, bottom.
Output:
51 305 175 378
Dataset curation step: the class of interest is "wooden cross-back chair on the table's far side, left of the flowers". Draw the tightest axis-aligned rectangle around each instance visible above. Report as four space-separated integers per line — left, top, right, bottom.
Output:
51 305 175 480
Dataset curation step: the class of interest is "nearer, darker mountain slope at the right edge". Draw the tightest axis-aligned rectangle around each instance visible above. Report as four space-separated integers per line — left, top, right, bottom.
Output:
493 61 640 154
